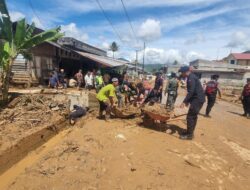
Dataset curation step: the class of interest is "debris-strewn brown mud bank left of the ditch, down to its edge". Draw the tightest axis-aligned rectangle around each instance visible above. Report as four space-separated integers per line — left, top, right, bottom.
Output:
0 94 69 151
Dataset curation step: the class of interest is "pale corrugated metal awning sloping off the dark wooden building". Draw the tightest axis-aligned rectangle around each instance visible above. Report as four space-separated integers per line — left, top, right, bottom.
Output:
75 51 126 67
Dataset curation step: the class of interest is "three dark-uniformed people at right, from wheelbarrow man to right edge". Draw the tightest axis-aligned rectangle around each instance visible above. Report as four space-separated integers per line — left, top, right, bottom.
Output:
174 66 250 140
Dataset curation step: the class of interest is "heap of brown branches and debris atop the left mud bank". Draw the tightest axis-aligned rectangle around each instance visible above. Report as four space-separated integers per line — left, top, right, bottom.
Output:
0 95 69 126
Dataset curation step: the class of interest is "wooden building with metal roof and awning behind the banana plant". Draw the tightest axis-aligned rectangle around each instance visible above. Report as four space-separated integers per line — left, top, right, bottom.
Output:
12 28 127 86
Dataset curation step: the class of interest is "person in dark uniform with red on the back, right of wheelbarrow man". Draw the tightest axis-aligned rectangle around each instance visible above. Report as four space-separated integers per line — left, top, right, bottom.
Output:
205 75 221 118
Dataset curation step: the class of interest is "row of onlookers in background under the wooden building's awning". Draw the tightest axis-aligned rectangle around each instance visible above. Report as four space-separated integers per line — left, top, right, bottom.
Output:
48 69 104 91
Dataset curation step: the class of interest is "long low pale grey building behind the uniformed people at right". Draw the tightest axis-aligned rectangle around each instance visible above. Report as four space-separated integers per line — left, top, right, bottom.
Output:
190 58 250 87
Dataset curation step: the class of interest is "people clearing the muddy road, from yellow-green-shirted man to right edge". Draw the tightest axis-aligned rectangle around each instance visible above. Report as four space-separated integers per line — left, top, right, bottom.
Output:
97 66 250 140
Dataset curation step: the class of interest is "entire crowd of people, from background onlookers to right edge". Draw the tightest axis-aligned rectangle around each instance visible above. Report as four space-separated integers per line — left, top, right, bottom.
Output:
49 66 250 140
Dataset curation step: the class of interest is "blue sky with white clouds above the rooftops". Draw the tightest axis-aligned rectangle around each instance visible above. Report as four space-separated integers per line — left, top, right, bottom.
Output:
6 0 250 64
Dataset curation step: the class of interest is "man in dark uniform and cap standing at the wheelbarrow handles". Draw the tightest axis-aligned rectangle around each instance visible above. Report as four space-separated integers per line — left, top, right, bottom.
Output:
179 66 205 140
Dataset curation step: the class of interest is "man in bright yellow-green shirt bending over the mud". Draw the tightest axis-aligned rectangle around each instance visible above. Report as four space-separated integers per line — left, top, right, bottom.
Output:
96 78 119 120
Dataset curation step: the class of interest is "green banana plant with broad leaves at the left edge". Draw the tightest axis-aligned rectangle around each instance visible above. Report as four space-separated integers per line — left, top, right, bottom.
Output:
0 0 63 102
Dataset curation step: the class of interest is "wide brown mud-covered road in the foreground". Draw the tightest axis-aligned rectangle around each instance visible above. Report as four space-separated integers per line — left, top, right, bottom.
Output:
0 91 250 190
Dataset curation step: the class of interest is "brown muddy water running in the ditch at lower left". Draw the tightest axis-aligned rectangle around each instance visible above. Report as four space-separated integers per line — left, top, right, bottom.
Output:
0 129 71 189
